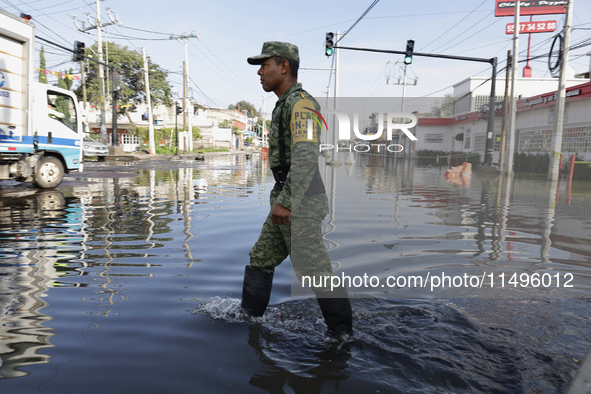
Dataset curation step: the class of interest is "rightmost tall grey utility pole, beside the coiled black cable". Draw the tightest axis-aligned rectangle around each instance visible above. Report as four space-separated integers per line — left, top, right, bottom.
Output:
548 0 574 181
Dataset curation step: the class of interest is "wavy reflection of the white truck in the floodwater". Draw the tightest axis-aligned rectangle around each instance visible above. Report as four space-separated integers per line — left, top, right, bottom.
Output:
0 190 85 378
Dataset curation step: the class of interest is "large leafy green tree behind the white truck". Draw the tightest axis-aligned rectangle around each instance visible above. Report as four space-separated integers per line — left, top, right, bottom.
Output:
76 42 173 125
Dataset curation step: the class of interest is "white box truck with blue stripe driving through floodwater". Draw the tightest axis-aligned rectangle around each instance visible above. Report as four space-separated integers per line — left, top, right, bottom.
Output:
0 10 84 189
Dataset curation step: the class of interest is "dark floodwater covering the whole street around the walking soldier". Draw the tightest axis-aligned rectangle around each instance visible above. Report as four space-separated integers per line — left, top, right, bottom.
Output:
0 154 591 393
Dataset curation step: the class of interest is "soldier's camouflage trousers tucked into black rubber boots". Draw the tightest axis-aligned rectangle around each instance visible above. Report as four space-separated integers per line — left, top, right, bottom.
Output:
249 190 332 291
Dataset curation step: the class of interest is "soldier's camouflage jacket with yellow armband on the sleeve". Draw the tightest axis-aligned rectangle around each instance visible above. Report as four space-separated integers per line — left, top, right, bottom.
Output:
269 83 326 210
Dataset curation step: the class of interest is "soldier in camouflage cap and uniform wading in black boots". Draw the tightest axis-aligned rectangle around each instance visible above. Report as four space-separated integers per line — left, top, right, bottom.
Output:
241 41 353 335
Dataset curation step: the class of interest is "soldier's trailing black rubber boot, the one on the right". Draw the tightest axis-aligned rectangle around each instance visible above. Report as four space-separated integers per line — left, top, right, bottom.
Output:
316 287 353 335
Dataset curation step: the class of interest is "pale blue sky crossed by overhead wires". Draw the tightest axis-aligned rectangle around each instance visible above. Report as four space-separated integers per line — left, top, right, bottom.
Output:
0 0 591 113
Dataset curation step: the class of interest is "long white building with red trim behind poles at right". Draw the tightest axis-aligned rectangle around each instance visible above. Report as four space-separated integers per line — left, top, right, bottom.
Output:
412 78 591 163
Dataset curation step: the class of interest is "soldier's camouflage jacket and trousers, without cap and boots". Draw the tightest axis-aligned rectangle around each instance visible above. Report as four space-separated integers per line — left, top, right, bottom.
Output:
250 83 332 292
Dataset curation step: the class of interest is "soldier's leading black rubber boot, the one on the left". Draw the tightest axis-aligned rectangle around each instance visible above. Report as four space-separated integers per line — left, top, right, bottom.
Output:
242 265 273 317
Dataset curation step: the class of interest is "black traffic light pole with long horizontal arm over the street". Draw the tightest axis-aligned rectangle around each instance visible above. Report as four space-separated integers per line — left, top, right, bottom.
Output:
334 46 497 166
